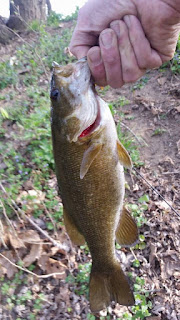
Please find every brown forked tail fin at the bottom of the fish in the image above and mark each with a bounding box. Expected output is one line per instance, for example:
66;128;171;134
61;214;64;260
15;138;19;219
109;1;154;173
89;263;134;312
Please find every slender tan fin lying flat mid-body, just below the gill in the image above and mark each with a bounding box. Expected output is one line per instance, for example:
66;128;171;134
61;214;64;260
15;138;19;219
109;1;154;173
80;142;102;179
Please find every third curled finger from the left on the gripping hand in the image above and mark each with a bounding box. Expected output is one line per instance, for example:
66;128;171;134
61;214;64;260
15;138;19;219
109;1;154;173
110;20;145;83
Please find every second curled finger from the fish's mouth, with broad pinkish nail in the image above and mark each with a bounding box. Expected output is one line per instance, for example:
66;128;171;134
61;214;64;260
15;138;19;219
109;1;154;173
99;28;124;88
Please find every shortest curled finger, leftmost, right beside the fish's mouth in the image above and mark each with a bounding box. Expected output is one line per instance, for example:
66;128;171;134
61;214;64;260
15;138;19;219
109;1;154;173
87;46;107;87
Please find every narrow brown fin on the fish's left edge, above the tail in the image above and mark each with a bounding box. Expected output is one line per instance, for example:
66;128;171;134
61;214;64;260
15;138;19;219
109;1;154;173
63;208;85;246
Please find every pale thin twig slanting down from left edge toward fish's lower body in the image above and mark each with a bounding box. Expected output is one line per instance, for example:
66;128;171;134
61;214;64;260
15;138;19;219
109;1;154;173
0;183;67;254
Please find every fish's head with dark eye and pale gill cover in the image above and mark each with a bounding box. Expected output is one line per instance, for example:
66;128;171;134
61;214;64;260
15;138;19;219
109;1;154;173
50;58;98;142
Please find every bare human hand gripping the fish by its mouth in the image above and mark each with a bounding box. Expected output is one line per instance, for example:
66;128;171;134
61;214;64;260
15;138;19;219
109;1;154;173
70;0;180;88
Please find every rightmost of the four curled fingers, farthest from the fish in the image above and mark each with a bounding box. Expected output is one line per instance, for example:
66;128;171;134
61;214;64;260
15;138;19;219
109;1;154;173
123;15;162;69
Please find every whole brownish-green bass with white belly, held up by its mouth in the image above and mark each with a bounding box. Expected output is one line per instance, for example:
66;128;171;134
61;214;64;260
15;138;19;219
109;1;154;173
50;58;138;312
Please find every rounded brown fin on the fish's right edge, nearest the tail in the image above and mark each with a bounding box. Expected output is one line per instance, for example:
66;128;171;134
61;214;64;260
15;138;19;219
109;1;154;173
116;207;138;247
